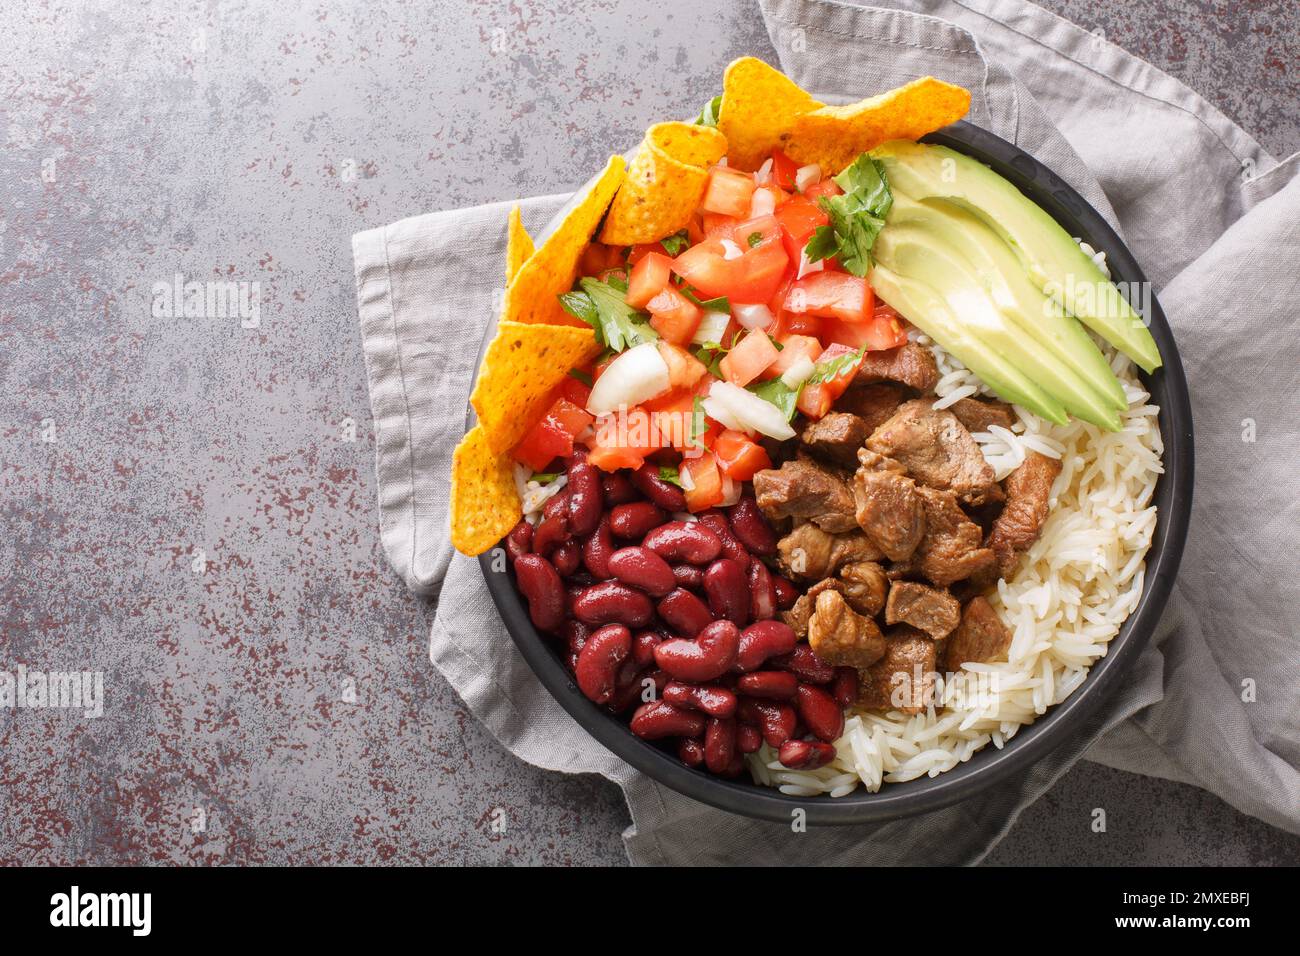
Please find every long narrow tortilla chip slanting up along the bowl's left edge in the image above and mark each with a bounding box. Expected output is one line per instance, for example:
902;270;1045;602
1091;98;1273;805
502;156;627;329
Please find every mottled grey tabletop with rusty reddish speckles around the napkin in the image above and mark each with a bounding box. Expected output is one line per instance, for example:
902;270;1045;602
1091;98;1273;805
0;0;1300;864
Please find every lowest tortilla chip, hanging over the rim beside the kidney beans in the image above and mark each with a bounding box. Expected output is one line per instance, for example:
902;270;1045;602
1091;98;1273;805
451;425;520;555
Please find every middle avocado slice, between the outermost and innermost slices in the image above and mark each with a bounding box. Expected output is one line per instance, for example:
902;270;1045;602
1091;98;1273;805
888;193;1128;424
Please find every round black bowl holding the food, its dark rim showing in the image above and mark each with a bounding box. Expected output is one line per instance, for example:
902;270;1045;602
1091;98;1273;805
471;122;1192;825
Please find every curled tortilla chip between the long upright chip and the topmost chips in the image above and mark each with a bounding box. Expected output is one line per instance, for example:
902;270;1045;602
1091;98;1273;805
601;122;727;246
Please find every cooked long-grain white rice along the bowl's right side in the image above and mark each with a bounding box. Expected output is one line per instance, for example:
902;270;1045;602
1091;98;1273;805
748;332;1164;796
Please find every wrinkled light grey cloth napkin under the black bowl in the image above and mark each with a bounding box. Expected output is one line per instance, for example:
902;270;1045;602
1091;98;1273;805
354;0;1300;864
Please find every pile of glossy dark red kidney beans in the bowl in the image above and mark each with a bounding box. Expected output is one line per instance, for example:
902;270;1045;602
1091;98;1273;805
506;450;858;777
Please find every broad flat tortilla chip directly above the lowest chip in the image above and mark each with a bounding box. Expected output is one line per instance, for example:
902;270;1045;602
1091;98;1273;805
469;321;601;451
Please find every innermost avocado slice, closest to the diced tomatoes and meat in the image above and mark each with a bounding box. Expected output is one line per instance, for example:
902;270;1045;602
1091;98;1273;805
868;219;1119;431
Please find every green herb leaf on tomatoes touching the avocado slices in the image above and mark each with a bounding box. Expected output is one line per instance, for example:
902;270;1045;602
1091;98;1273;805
803;153;893;276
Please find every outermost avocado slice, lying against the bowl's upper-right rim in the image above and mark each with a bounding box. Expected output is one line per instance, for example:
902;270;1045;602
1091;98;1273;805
871;140;1161;372
